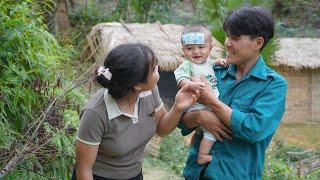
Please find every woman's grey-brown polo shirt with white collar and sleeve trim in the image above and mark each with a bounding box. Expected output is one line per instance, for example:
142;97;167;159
77;86;162;179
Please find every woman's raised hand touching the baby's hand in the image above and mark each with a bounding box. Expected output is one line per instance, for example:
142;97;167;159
175;84;200;111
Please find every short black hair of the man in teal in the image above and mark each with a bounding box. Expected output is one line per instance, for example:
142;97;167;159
223;6;274;50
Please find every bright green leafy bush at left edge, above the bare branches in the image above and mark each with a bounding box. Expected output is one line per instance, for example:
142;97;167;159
0;1;65;132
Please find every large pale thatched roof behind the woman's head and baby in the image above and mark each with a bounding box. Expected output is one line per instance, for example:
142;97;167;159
87;22;222;71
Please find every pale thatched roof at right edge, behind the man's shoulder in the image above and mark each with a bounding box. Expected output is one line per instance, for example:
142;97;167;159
274;38;320;70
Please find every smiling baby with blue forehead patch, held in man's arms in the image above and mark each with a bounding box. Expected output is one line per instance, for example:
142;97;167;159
174;25;226;164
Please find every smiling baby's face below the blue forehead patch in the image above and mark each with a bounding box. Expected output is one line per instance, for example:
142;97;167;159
182;41;212;64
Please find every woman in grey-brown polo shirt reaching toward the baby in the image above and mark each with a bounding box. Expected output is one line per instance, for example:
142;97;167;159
72;44;199;180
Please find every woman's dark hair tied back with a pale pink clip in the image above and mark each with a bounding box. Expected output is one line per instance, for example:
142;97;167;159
96;43;158;99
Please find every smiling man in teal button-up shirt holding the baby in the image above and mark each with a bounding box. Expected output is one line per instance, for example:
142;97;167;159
179;7;287;180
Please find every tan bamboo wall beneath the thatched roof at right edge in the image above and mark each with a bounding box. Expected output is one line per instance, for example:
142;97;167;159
276;68;320;123
